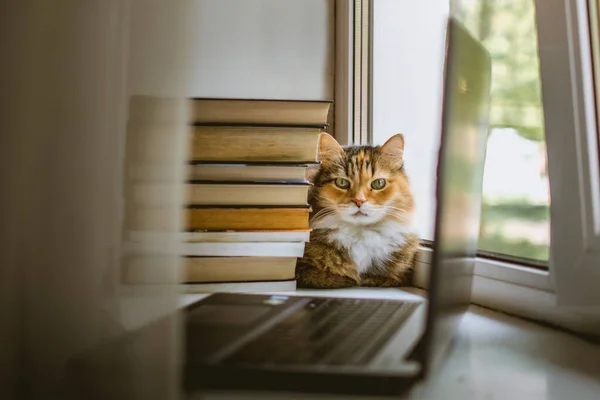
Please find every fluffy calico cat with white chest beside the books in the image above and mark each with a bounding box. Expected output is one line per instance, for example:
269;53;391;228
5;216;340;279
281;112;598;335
296;133;419;288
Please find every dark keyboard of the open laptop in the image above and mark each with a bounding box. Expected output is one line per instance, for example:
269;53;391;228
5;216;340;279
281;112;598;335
223;298;419;365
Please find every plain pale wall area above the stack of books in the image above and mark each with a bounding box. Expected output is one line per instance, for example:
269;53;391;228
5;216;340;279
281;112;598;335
131;0;334;100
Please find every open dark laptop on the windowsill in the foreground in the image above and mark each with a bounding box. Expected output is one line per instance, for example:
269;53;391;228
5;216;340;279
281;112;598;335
183;18;491;394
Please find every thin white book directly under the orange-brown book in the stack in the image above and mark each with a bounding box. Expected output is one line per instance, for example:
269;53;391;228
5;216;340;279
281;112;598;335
128;229;311;243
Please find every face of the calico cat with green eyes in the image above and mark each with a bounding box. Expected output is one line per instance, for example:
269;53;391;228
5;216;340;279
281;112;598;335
311;134;414;229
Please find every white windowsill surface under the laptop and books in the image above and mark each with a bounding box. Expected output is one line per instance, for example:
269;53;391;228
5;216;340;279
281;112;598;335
182;288;600;400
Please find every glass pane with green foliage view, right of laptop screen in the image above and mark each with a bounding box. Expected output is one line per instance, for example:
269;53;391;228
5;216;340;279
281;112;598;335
457;0;550;261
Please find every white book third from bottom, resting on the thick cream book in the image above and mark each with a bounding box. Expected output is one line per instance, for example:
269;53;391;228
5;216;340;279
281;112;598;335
123;242;304;257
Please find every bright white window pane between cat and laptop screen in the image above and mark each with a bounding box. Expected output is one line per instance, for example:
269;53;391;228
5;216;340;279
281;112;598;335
371;0;449;240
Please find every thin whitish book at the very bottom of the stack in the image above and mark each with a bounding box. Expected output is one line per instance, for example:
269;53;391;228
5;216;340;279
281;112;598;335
179;280;296;294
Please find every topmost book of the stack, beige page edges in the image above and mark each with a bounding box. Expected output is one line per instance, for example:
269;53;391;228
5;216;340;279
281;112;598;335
129;96;332;126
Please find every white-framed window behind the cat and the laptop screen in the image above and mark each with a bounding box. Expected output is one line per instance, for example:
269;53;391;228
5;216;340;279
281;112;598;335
336;0;600;333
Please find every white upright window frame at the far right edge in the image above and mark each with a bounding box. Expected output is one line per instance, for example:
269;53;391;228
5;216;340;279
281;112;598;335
535;0;600;310
